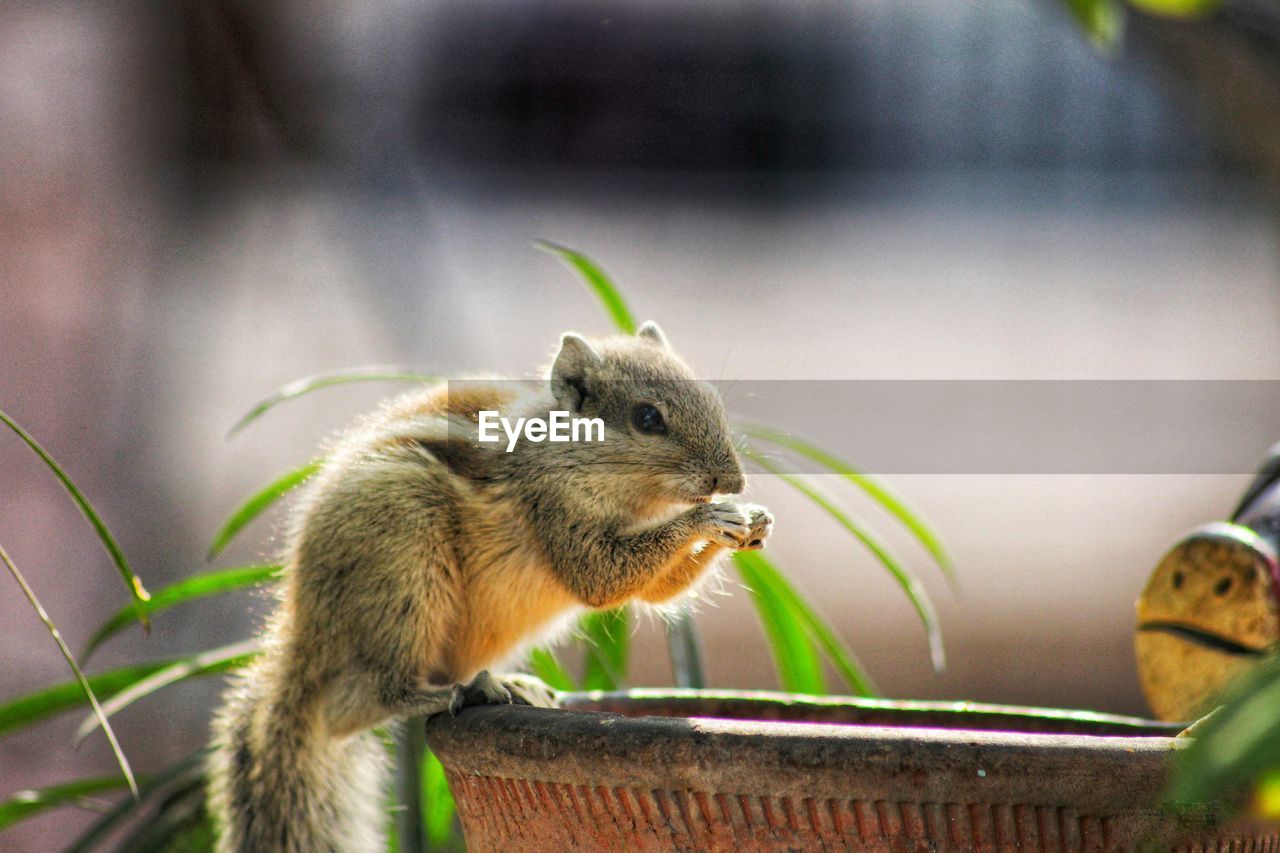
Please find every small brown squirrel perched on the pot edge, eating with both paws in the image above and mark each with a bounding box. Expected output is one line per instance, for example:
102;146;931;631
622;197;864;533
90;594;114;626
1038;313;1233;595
207;323;773;853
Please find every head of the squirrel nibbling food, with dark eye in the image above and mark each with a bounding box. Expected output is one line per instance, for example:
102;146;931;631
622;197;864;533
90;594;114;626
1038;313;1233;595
550;321;746;503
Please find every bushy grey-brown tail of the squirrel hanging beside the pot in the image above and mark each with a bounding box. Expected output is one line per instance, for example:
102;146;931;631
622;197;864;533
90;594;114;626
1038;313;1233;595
209;649;388;853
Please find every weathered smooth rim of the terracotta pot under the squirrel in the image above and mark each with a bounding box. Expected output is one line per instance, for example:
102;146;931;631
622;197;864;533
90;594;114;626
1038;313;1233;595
428;690;1184;811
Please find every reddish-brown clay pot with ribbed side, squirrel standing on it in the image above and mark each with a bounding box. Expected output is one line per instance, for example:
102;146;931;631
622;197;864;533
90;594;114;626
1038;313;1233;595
428;690;1280;850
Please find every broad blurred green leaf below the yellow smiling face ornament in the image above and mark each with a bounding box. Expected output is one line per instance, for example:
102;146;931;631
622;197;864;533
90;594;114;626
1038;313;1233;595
1167;656;1280;803
